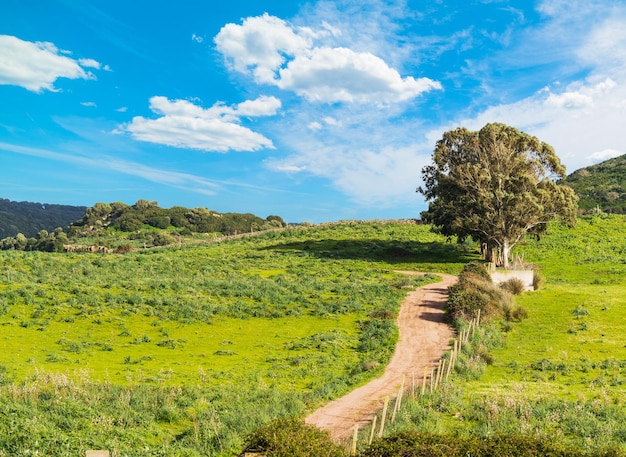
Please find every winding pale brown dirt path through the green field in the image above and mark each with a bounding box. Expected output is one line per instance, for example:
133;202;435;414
305;271;457;441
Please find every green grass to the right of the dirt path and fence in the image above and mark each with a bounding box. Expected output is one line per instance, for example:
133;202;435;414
378;216;626;455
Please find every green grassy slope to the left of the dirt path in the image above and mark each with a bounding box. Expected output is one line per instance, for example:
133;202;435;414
0;223;472;456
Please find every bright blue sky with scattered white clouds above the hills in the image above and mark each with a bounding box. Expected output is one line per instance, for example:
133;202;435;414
0;0;626;222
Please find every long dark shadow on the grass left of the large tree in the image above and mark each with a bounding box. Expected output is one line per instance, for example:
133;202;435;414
264;239;477;265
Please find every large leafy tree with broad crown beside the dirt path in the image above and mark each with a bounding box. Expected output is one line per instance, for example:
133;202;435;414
418;123;578;268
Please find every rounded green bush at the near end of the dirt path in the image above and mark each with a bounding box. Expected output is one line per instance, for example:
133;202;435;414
244;418;346;457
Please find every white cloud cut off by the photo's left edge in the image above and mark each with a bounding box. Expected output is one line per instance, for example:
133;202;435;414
0;35;100;92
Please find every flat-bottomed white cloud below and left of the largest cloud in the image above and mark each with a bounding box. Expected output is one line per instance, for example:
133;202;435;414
117;96;281;152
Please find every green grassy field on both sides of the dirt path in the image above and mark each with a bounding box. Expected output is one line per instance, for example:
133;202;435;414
0;215;626;457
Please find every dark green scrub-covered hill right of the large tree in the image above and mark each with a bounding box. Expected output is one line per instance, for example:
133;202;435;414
563;155;626;214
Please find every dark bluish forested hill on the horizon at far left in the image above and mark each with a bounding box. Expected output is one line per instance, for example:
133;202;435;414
0;198;87;239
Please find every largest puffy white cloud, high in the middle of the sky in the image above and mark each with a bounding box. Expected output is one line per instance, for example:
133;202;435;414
214;14;442;104
